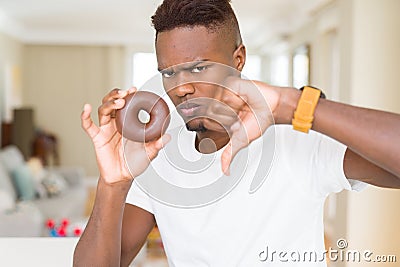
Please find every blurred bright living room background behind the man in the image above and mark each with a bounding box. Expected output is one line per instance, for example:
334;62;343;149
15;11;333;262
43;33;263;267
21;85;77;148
0;0;400;266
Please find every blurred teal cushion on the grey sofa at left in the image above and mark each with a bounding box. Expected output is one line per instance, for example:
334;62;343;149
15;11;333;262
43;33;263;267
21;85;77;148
11;164;35;200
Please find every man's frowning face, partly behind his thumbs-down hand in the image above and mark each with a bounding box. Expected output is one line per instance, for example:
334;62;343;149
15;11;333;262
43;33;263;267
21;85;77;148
156;26;245;132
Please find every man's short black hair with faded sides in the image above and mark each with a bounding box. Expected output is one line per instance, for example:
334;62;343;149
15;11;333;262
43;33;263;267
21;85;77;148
151;0;242;46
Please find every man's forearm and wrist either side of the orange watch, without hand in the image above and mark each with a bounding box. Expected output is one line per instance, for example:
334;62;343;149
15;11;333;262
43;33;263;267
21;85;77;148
274;89;400;177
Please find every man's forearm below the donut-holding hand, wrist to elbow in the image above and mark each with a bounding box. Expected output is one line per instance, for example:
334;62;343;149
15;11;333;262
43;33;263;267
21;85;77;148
74;179;132;267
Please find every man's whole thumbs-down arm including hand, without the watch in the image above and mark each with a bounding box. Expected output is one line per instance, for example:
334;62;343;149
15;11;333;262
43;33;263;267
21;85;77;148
222;81;400;188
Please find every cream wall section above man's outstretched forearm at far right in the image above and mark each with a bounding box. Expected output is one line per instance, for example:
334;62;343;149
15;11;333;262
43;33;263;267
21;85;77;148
351;0;400;112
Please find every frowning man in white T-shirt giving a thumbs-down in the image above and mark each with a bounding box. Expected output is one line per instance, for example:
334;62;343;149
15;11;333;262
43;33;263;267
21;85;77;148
74;0;400;266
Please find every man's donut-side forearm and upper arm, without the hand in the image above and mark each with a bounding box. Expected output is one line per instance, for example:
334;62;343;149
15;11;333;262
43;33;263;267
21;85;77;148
74;180;155;266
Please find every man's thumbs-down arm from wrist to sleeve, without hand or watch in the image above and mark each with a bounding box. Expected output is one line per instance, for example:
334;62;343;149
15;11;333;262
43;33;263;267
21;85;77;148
274;89;400;188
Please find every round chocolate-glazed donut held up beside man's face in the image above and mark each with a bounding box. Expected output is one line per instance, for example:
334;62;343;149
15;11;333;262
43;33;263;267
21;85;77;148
115;91;170;143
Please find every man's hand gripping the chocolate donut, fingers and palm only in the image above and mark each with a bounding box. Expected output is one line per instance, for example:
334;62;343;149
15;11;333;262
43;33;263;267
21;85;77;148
81;88;170;184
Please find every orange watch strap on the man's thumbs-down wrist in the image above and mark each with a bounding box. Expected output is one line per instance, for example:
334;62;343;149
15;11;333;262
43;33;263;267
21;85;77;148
292;86;321;133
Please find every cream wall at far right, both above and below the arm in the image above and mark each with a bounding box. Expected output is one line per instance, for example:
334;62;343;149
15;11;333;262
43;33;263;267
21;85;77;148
347;0;400;266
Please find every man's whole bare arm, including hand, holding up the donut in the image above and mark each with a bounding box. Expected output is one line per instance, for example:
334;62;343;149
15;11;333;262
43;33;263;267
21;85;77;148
74;88;169;267
